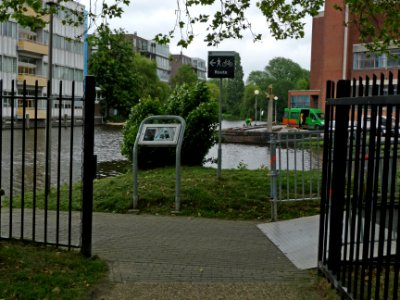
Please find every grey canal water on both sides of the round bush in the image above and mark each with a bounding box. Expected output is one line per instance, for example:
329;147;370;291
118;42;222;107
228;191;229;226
1;121;318;191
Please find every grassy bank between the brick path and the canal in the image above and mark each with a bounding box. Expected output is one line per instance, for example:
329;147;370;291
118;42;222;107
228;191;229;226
3;167;320;220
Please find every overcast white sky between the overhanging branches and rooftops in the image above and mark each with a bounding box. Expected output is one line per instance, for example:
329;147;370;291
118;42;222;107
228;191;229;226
81;0;311;80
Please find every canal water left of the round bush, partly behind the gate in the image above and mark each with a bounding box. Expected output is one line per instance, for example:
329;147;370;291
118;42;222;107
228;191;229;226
0;126;128;195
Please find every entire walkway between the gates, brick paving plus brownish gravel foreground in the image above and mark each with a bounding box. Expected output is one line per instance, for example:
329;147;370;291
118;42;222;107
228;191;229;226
92;213;324;299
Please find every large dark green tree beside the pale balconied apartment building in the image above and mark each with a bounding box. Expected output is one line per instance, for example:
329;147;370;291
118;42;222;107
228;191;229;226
89;26;170;119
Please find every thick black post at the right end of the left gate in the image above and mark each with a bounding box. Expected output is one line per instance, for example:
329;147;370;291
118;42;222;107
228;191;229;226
81;76;96;256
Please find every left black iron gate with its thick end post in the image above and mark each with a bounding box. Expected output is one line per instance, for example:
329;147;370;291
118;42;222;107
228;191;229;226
0;76;96;256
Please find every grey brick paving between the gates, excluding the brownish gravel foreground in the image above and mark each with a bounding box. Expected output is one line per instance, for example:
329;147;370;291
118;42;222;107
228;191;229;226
92;213;311;283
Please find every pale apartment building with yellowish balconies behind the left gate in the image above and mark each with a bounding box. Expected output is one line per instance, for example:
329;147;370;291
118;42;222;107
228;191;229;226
0;2;87;118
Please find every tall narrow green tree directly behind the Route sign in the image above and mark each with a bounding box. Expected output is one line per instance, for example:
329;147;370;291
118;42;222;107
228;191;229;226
223;53;244;116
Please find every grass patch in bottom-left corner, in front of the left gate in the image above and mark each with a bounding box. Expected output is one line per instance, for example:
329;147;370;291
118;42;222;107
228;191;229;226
0;241;108;300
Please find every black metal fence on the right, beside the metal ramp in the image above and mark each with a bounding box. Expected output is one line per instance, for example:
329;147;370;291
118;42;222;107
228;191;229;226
318;72;400;299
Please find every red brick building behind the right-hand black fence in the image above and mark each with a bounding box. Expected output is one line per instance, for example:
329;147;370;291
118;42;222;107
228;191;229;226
288;0;400;109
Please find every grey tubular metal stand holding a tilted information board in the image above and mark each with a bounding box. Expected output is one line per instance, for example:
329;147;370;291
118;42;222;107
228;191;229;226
132;115;186;213
